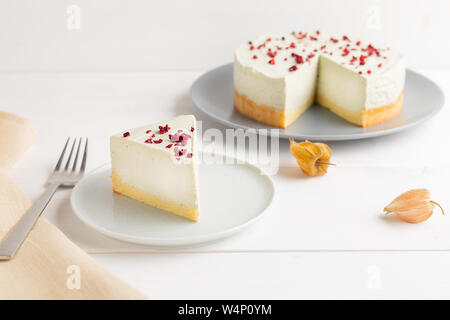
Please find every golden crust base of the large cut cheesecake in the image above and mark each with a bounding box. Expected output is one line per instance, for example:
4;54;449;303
234;89;403;128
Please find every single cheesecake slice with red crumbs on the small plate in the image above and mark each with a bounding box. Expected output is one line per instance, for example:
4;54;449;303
110;115;199;221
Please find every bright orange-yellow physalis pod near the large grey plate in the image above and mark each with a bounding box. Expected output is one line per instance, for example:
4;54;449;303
289;139;332;177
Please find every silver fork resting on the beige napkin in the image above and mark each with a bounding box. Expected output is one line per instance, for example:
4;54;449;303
0;137;88;260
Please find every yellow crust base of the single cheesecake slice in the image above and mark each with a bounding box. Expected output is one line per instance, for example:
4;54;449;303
111;171;198;221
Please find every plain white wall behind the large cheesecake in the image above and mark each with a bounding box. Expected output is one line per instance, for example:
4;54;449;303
0;0;450;71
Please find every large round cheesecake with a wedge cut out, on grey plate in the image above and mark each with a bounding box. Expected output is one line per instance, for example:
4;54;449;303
234;31;405;128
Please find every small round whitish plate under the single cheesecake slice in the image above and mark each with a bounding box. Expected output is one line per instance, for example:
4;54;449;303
71;156;275;247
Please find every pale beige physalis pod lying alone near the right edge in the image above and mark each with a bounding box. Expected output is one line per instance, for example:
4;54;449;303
384;189;444;223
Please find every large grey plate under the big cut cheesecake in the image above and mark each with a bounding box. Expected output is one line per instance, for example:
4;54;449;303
191;63;444;141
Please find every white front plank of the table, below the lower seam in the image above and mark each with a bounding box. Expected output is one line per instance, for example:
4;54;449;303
95;253;450;299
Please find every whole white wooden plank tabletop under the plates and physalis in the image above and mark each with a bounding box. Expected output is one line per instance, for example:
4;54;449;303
0;69;450;299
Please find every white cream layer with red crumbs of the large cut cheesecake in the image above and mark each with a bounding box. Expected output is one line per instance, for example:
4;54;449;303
234;31;405;111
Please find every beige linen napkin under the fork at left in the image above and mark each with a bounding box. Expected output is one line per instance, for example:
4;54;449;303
0;112;145;299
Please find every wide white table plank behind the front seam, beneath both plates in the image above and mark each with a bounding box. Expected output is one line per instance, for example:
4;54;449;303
0;71;450;252
